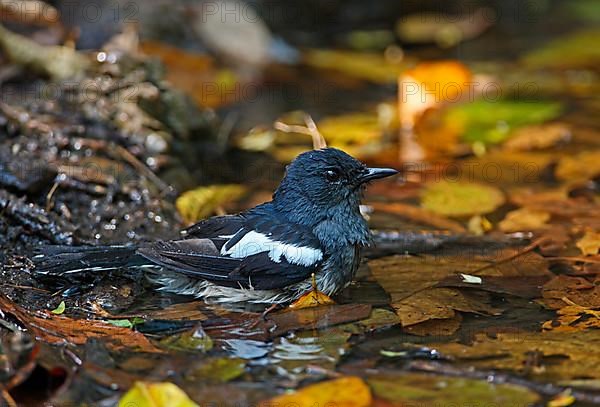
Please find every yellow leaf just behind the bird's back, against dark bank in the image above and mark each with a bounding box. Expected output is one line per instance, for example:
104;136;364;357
175;185;246;223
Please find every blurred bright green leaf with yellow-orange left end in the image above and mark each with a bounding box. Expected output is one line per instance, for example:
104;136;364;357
444;100;562;144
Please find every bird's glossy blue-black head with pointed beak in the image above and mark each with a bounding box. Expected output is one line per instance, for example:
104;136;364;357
273;148;398;222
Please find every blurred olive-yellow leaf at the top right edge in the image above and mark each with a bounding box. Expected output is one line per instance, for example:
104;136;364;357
523;30;600;68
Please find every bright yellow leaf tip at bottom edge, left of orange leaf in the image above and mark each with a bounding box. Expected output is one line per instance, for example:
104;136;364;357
119;382;198;407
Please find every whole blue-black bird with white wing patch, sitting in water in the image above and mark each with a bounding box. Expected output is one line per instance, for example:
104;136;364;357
33;148;397;304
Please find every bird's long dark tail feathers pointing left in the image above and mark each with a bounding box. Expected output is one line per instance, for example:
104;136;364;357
32;246;151;277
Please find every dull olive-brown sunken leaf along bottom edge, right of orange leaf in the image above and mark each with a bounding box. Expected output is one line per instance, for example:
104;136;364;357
367;373;539;407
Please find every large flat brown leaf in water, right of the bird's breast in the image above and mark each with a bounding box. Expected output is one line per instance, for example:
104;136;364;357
369;253;548;326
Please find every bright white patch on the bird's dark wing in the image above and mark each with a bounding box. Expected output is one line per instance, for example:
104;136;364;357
221;230;323;267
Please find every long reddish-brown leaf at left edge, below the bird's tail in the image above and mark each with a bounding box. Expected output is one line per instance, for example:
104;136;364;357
0;296;162;353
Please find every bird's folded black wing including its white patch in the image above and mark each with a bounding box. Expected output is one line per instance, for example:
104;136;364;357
138;217;323;290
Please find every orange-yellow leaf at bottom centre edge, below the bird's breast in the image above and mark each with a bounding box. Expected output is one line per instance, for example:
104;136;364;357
261;376;372;407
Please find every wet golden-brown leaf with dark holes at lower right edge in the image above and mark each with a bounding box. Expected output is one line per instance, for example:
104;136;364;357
431;329;600;381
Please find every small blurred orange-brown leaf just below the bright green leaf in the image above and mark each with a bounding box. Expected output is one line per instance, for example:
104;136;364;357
504;123;571;151
